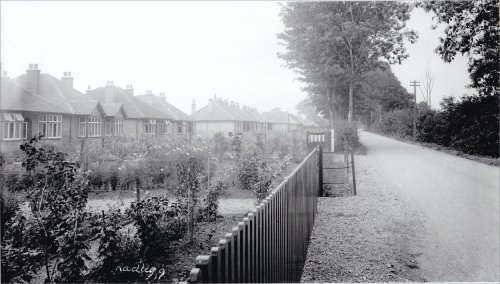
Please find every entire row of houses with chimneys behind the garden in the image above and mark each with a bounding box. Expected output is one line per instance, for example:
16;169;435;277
0;64;317;152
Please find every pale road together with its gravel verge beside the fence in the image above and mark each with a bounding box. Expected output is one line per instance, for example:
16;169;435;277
303;132;500;282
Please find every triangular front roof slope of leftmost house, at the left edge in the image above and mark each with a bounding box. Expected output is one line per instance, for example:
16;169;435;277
0;78;71;114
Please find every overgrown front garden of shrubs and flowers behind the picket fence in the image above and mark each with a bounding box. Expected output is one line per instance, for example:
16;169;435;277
0;130;306;283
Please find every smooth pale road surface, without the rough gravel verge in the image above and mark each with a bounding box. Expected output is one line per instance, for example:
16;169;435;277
359;132;500;282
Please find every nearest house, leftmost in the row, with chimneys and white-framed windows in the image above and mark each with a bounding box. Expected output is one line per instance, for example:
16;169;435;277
0;64;127;152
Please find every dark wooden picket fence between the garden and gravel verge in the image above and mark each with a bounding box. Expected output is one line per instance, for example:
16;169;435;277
188;148;322;283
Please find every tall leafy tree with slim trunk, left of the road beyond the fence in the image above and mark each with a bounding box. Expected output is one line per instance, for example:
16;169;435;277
278;2;417;121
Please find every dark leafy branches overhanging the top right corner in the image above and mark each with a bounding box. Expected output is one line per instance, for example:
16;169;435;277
418;0;500;95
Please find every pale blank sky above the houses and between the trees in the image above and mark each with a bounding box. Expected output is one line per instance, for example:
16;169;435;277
0;1;470;113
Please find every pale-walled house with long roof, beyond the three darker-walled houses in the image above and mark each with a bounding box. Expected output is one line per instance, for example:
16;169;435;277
191;97;267;137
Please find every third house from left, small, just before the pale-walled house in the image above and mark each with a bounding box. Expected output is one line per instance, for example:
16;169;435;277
135;90;195;139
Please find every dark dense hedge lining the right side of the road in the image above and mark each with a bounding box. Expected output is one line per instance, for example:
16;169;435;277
375;96;499;157
